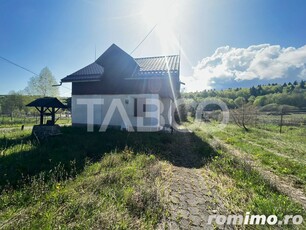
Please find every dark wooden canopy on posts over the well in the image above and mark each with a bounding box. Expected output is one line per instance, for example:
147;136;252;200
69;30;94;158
26;97;67;125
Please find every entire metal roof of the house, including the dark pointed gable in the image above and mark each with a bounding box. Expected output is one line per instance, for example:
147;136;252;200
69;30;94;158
62;44;180;82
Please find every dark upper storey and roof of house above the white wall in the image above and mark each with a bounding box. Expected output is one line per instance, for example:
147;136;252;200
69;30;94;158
62;44;180;99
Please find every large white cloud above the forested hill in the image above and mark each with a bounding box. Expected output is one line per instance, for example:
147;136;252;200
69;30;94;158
182;44;306;91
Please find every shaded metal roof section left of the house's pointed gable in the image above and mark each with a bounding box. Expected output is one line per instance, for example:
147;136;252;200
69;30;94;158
62;62;104;82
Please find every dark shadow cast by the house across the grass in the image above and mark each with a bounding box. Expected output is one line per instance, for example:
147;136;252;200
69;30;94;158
0;127;216;191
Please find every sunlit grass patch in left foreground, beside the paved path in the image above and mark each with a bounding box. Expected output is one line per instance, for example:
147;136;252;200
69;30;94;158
0;149;163;229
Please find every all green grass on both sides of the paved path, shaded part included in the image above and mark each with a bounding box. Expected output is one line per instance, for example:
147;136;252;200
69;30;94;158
0;124;306;229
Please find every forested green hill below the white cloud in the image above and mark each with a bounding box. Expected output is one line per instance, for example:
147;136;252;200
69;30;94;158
182;80;306;108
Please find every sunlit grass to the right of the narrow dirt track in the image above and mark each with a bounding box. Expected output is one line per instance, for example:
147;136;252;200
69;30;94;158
203;125;306;191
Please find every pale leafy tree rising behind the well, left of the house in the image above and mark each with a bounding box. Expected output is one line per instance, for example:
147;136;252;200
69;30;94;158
25;67;59;97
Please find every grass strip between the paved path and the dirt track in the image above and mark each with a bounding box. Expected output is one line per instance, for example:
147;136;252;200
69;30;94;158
196;127;306;229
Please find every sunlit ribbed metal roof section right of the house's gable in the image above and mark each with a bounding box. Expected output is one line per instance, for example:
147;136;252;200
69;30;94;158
134;55;180;77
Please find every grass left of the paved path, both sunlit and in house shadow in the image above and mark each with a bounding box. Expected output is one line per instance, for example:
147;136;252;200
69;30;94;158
0;127;213;229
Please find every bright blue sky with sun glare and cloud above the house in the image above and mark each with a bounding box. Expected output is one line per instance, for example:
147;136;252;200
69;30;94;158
0;0;306;96
